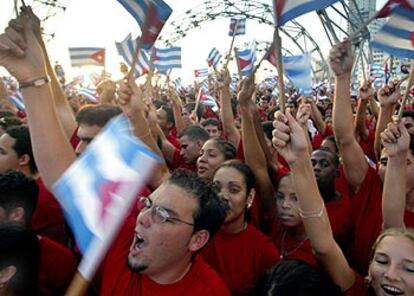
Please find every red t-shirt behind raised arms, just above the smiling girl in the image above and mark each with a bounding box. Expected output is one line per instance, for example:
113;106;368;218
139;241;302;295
349;167;414;275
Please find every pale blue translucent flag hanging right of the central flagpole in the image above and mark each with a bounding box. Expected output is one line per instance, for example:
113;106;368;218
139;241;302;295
282;53;312;95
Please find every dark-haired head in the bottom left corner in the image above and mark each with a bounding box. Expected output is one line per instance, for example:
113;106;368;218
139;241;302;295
0;222;40;296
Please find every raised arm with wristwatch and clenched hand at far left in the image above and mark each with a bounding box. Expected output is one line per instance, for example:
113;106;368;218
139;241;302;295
0;12;76;188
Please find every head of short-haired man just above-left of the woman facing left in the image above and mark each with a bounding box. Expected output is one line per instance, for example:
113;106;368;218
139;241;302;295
179;125;210;165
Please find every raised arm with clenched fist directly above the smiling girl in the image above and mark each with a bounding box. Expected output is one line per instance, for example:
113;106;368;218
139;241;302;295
381;122;410;229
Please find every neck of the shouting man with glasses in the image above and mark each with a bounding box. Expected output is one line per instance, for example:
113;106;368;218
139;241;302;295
148;253;193;285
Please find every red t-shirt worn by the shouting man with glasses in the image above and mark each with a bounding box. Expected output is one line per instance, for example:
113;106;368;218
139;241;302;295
101;217;230;296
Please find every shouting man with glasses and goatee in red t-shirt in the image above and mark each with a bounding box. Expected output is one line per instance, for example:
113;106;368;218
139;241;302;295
101;170;230;295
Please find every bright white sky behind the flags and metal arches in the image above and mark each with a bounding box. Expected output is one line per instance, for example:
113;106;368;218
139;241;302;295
0;0;385;83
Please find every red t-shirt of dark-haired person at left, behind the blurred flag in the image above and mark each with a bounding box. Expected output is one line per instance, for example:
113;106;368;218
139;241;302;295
32;178;68;245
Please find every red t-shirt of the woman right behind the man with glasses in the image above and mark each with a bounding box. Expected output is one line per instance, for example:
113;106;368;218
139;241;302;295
201;225;280;295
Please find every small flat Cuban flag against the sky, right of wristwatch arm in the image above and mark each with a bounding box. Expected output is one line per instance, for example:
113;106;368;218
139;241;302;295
69;47;105;67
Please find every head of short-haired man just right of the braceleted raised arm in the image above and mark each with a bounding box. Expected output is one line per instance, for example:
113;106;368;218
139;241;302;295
311;147;339;202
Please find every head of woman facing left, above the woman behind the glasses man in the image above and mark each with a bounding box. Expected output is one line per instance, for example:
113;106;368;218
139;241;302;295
197;138;236;180
